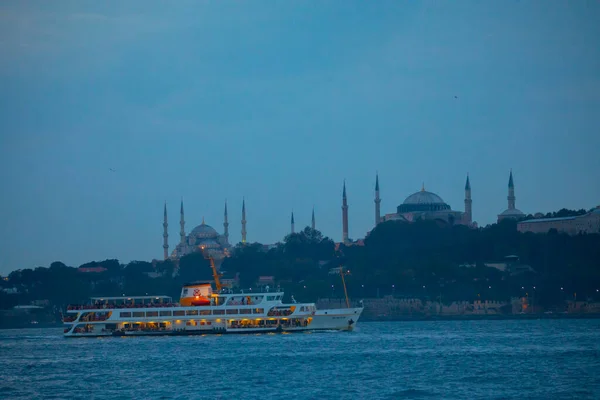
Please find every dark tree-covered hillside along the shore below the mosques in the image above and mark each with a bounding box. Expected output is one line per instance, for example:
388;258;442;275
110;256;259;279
0;214;600;308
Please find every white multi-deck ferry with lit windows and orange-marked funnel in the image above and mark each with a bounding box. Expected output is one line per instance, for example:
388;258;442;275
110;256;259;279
63;260;363;337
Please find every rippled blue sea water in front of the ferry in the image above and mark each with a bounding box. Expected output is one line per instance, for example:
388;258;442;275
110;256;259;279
0;319;600;400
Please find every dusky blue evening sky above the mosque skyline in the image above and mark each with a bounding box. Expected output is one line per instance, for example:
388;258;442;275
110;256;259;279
0;0;600;274
